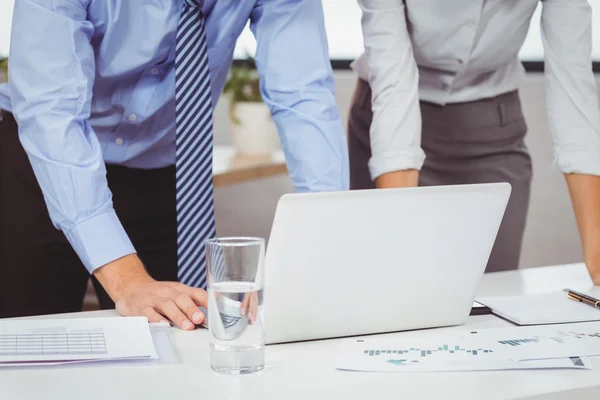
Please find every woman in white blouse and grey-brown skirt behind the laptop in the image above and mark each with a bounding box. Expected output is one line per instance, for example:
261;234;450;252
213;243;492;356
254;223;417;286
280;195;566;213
349;0;600;284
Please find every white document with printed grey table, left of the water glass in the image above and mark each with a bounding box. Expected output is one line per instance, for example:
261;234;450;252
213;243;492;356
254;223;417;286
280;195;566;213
0;317;158;367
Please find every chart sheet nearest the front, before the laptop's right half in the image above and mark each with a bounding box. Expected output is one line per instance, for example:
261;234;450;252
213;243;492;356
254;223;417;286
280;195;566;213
336;335;591;372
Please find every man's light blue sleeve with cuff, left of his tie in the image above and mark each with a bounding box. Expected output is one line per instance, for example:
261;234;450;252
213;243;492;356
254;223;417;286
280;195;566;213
9;0;135;272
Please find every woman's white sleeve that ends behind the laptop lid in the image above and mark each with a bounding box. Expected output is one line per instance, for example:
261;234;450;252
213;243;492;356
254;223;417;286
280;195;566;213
358;0;425;179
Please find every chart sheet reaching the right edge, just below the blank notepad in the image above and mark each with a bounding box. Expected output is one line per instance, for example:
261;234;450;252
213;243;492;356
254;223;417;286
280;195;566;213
461;322;600;361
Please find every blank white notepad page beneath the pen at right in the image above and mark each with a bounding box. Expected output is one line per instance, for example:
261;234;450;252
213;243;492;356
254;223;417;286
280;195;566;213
477;291;600;325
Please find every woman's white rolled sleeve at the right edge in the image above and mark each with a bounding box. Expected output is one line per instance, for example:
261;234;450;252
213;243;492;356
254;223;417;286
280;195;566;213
541;0;600;175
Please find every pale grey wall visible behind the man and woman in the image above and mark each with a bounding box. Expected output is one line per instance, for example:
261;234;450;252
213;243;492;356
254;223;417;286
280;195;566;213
215;72;600;267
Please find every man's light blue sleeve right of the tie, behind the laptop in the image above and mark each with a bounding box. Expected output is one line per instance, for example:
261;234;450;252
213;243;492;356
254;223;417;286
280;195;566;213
251;0;349;192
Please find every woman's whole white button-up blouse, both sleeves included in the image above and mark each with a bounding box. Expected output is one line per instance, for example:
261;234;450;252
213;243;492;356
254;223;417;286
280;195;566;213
353;0;600;179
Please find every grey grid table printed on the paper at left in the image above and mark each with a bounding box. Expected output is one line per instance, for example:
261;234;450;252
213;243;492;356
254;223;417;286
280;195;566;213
0;331;107;356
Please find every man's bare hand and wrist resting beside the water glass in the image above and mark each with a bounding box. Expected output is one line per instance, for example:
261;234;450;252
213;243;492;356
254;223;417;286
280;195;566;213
94;254;207;330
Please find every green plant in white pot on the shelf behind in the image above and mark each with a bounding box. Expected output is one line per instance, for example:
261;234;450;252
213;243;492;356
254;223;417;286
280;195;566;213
224;57;279;156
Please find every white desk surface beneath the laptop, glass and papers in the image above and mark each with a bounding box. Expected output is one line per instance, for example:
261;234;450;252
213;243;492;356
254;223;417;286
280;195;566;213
0;264;600;400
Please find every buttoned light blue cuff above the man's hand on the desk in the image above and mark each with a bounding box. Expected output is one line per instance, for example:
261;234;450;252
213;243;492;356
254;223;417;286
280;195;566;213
65;210;136;274
